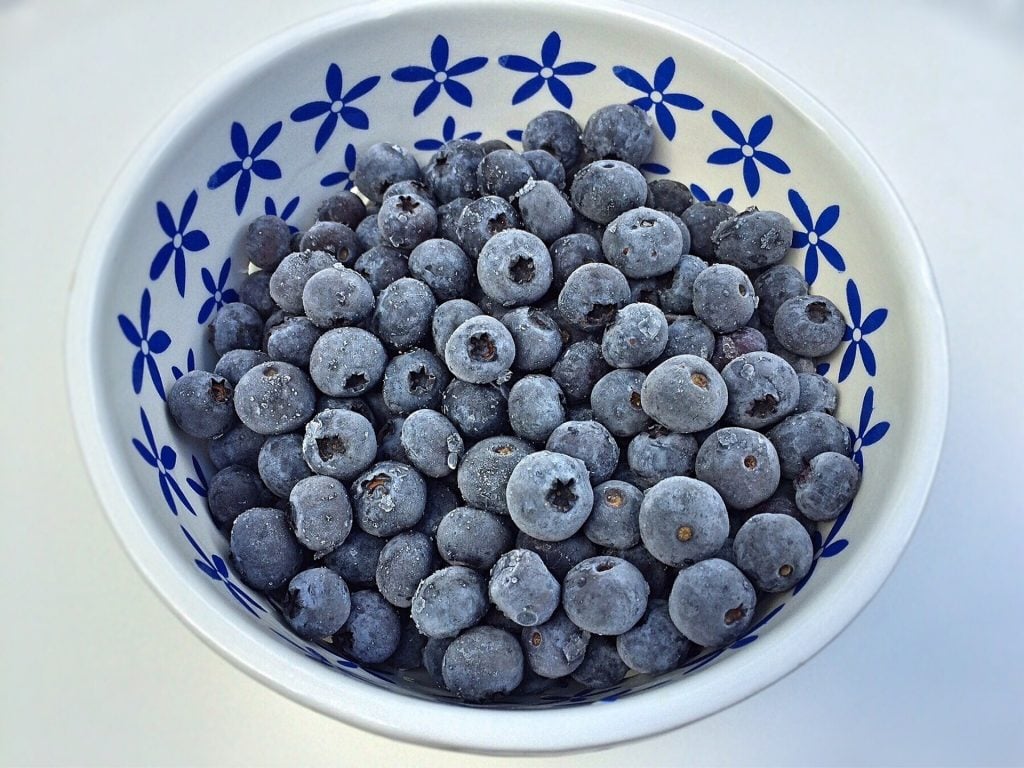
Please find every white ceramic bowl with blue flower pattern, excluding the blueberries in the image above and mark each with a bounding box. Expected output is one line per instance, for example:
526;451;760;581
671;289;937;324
68;0;947;753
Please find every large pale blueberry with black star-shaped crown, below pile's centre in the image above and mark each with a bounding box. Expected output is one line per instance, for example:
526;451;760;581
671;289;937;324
505;451;594;542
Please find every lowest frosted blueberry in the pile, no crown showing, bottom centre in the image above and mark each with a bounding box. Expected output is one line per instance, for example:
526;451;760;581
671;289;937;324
441;627;523;701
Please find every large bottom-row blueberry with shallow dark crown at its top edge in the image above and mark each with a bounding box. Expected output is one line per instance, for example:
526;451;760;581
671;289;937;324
562;555;650;635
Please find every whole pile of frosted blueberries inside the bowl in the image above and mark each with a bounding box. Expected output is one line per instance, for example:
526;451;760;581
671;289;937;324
168;104;859;701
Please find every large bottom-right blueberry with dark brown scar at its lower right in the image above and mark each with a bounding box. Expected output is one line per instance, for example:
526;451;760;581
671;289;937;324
669;559;757;648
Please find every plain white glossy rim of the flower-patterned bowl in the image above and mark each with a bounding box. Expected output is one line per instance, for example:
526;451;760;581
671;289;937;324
66;0;949;754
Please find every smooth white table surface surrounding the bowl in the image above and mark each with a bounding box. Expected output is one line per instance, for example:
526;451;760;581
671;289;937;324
0;0;1024;768
